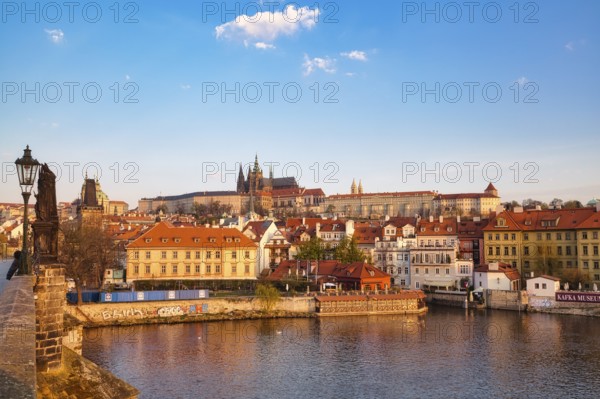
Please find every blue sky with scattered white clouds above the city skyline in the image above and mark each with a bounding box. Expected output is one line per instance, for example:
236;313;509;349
0;0;600;207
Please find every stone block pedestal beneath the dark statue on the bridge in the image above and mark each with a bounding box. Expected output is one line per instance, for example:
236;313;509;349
35;264;66;372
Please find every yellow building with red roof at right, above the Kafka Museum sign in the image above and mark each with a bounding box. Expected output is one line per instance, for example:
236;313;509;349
483;208;600;288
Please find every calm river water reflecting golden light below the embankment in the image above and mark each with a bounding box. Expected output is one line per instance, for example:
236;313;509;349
84;307;600;399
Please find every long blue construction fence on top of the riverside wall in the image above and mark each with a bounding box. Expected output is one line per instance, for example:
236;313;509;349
67;290;208;304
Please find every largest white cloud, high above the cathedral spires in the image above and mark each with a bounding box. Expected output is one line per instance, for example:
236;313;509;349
215;5;320;48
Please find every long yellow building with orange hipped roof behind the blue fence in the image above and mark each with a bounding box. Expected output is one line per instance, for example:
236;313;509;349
127;222;257;281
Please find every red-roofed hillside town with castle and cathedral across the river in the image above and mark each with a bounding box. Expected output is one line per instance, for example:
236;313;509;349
0;157;600;298
